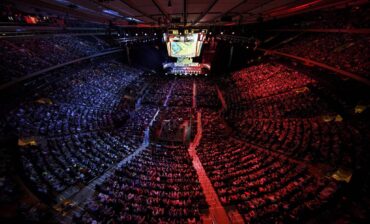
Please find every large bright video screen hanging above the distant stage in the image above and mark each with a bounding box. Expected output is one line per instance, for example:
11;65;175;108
163;33;204;58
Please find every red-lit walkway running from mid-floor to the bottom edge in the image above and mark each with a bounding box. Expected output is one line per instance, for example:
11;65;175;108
188;112;243;224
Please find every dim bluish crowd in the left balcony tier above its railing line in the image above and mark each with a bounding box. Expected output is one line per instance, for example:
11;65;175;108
0;35;110;84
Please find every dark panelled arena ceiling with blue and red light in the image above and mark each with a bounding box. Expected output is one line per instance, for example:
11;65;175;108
13;0;367;27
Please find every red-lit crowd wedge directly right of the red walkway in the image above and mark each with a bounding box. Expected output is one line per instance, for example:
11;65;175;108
197;110;338;223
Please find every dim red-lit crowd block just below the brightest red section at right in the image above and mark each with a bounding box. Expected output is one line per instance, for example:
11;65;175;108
231;118;361;167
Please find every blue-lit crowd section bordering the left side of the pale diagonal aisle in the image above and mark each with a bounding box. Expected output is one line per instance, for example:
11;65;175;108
20;132;142;201
